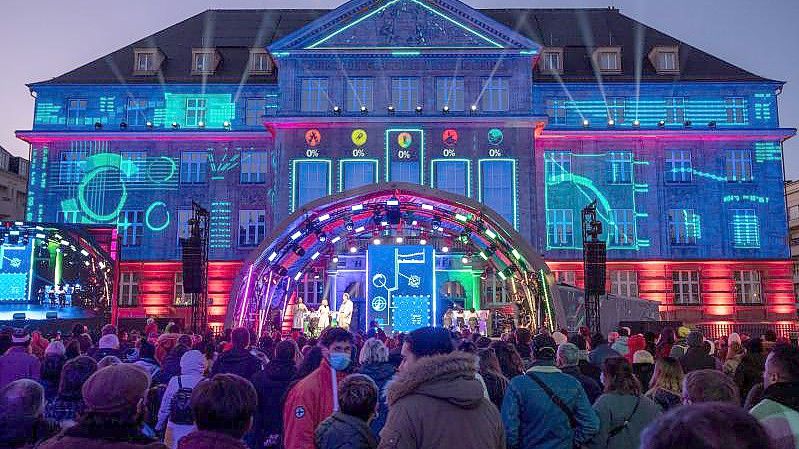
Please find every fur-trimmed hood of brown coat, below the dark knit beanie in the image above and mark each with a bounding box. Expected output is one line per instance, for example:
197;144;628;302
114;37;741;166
386;351;484;408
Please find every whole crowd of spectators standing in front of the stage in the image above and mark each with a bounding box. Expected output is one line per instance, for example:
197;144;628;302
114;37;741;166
0;321;799;449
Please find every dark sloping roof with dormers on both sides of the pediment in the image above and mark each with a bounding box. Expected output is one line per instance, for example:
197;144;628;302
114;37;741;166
36;8;770;85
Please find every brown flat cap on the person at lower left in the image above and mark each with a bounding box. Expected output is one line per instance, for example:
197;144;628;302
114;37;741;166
82;363;150;414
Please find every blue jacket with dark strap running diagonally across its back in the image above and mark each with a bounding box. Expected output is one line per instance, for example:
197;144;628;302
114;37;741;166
502;365;599;449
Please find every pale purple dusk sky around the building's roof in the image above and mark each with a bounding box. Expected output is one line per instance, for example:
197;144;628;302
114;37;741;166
0;0;799;179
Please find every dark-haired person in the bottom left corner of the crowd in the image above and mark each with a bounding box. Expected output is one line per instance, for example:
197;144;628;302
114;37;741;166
0;379;59;449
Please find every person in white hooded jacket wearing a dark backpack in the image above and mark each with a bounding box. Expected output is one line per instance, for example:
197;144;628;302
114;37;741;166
155;350;205;449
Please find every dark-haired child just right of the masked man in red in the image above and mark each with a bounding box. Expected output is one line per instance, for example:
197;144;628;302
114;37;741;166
315;374;378;449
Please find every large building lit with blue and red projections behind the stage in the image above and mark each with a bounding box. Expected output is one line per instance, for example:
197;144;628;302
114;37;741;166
18;0;796;326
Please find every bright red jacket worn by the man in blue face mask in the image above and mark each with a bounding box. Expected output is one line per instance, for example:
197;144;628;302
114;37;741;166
283;359;346;449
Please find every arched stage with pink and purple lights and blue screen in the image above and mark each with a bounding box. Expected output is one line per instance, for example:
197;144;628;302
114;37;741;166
225;183;563;335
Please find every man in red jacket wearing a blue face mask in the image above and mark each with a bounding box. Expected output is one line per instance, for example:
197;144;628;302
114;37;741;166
283;327;353;449
